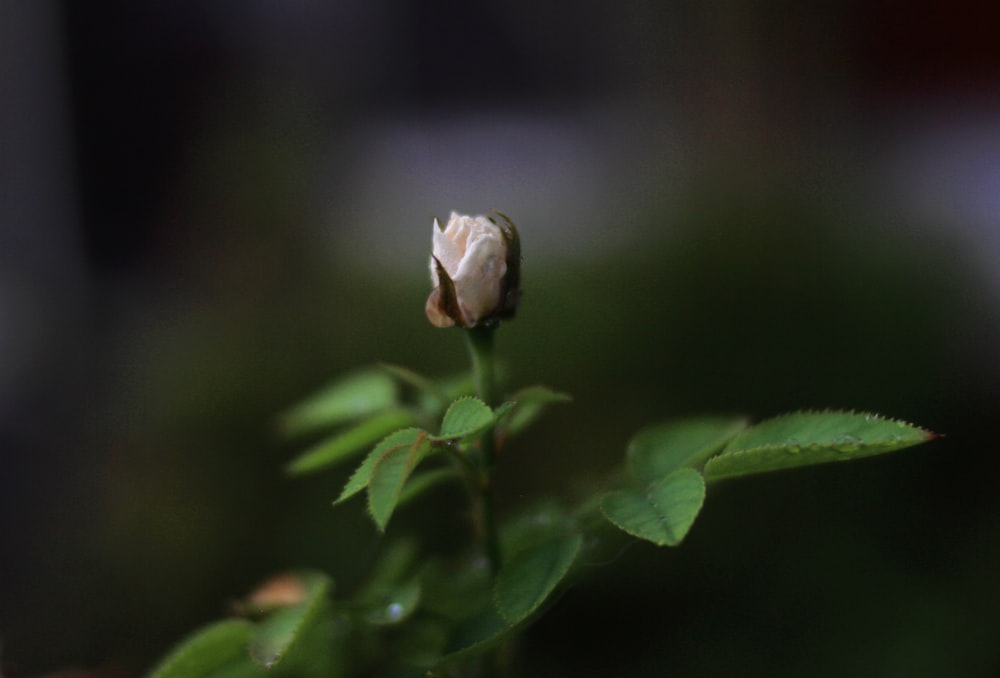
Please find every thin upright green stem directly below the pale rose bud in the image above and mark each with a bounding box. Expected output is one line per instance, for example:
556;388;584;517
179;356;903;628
465;325;502;576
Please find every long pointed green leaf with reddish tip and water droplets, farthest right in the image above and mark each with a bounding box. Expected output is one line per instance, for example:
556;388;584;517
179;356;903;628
705;411;935;480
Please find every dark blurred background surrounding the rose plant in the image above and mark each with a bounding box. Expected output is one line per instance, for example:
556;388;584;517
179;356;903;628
0;0;1000;677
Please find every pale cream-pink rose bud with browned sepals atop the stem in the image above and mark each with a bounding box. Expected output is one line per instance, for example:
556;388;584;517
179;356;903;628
426;212;521;327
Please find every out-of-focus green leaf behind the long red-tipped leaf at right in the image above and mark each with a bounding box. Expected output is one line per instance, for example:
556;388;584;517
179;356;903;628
625;417;747;482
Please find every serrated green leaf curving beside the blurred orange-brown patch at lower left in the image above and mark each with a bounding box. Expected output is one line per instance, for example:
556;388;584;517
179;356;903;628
250;572;331;669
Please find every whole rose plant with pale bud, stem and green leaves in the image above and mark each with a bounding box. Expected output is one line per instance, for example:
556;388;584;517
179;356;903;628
143;213;934;678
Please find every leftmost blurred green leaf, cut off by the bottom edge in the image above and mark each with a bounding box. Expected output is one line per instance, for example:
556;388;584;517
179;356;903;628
147;619;253;678
